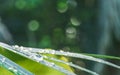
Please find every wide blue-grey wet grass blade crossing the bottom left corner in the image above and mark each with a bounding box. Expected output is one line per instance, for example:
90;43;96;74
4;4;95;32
0;54;33;75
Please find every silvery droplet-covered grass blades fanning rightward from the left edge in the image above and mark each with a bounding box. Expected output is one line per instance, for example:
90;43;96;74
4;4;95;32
0;43;120;75
